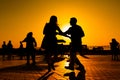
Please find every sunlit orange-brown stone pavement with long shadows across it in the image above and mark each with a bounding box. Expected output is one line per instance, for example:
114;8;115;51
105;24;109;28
0;55;120;80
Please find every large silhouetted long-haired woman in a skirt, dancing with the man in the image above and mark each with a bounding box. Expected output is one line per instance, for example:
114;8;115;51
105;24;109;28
41;16;62;71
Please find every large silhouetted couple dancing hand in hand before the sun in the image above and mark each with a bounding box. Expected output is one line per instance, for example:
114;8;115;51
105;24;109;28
41;16;85;72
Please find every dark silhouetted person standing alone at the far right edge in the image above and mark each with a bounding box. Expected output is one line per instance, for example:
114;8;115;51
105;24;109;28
110;38;119;60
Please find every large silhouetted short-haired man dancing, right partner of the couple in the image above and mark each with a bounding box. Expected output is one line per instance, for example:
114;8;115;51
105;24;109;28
65;17;85;71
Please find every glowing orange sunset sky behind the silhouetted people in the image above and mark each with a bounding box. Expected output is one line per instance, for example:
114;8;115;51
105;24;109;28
0;0;120;48
